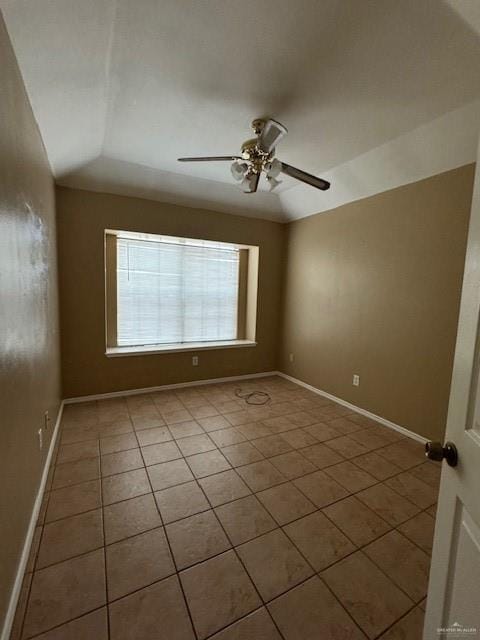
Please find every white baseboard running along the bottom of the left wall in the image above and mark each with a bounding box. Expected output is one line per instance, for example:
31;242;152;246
0;401;64;640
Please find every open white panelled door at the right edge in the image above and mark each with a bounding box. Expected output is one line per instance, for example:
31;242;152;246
423;146;480;640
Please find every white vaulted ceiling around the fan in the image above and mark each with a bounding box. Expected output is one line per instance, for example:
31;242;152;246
0;0;480;220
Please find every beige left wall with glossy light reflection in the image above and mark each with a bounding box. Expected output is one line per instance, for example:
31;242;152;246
0;14;60;626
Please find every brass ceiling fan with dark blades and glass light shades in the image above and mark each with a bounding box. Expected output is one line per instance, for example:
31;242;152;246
178;118;330;193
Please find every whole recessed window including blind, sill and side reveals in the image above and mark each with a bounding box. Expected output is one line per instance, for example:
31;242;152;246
105;231;258;355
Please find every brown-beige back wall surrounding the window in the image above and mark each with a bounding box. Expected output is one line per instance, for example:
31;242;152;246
57;187;285;398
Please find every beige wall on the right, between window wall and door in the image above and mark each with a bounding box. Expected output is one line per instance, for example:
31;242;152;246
280;165;474;439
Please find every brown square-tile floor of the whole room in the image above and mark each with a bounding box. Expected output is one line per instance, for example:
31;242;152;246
11;377;440;640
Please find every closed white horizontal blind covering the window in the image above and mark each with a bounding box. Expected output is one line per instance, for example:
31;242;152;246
117;237;239;346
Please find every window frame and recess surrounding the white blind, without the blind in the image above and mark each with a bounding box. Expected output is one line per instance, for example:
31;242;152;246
104;229;259;357
